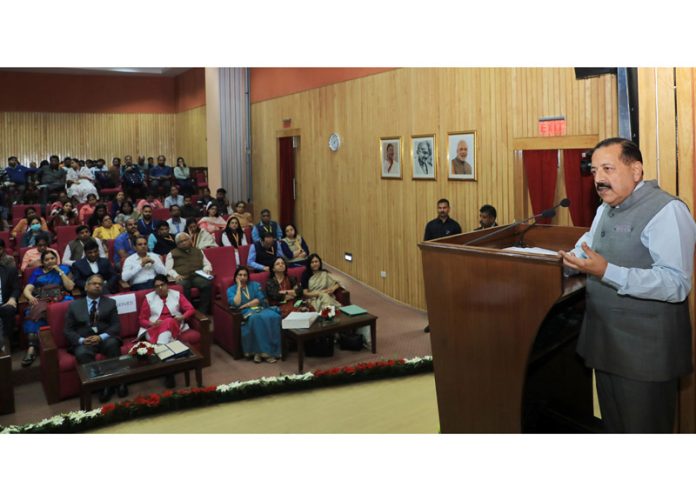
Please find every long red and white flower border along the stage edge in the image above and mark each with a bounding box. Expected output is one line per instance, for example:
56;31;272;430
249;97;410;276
0;354;433;433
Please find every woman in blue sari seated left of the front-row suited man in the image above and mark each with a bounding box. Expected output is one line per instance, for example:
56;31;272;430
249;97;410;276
22;249;75;367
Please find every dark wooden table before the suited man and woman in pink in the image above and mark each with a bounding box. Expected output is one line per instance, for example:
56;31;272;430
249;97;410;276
77;346;204;411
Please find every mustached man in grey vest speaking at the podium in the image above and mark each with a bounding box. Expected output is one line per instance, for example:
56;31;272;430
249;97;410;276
561;138;696;433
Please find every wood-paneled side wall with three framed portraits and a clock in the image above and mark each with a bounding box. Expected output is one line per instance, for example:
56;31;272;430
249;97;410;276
252;68;617;308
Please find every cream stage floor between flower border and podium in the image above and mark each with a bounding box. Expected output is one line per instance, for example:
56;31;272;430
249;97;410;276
89;374;439;433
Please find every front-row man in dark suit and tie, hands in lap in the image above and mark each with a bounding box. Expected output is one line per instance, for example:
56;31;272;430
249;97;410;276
65;274;128;403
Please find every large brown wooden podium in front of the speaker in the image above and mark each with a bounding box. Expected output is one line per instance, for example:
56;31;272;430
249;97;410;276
420;224;592;433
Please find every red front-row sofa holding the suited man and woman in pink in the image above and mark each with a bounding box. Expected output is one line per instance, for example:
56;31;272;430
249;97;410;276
39;285;211;404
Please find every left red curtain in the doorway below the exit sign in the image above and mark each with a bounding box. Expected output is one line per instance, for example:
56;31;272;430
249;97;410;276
522;150;558;224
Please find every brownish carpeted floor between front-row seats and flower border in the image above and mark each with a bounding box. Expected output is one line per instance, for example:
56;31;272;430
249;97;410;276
0;264;434;425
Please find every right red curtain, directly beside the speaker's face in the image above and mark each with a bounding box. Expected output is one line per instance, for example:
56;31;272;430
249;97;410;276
563;150;600;226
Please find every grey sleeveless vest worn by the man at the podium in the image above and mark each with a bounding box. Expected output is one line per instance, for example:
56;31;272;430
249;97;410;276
578;181;692;381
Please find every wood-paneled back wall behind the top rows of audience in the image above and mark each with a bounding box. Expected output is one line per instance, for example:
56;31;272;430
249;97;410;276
0;106;206;165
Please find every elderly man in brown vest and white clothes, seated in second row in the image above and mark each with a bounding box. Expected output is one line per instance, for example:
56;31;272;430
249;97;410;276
165;233;213;314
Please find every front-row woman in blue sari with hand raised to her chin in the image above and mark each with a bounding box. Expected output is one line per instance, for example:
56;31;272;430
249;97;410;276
227;266;281;363
